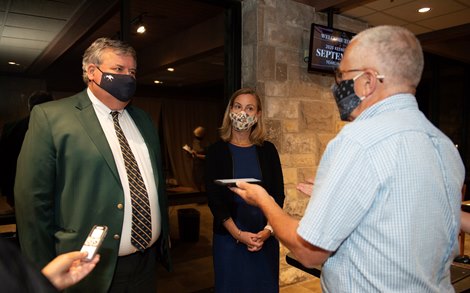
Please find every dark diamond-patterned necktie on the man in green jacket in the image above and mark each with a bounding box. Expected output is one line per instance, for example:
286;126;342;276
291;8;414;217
111;111;152;251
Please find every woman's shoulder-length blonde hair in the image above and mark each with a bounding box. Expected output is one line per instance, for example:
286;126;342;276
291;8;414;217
219;88;266;145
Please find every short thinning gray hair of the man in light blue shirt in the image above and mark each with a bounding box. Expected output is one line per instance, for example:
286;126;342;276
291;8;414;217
354;25;424;88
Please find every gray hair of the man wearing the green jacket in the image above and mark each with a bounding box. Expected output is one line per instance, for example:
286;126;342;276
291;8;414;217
82;38;137;84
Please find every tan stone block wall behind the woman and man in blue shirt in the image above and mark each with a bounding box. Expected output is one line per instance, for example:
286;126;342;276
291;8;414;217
242;0;367;286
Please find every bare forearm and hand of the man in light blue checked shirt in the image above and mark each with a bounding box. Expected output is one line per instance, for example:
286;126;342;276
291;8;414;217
231;181;331;267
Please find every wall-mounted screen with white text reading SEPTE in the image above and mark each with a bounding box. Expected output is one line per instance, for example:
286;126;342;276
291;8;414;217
308;23;355;73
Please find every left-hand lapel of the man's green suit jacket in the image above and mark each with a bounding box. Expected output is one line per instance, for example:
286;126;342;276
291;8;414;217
76;90;121;182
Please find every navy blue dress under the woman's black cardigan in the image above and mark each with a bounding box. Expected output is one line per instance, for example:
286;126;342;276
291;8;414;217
213;144;279;293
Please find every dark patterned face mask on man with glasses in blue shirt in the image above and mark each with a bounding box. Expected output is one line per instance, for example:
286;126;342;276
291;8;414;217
331;79;362;121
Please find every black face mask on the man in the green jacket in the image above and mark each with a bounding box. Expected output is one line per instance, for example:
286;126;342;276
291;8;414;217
93;67;136;102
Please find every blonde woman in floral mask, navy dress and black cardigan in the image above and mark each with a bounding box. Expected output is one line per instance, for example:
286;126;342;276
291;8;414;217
205;88;284;293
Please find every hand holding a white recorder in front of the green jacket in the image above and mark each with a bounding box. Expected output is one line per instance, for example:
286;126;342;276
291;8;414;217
41;251;100;290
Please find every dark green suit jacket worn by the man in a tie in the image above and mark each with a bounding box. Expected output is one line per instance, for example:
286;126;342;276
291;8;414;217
15;91;171;292
